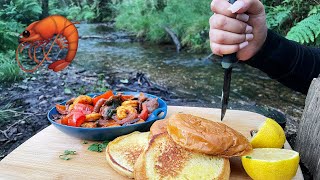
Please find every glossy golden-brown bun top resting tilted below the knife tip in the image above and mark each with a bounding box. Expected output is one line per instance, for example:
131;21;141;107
167;114;252;157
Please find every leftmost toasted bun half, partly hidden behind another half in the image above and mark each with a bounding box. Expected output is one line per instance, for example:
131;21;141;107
106;131;149;178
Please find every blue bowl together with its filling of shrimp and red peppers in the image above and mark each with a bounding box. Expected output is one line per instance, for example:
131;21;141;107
47;90;167;141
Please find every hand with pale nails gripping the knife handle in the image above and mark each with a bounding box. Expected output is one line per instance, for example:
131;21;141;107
209;0;268;61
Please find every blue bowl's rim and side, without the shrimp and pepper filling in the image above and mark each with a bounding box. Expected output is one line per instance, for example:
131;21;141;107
47;92;167;141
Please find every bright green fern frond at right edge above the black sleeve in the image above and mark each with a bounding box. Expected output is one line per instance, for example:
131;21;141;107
286;13;320;44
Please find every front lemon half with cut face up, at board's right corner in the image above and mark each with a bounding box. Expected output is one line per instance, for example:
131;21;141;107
241;148;300;180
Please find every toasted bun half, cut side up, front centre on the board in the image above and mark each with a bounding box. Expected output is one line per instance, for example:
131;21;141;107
134;132;230;180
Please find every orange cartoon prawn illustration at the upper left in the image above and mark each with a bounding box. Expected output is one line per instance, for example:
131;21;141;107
16;15;79;72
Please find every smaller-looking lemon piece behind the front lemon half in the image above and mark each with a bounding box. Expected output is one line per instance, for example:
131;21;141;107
250;118;286;148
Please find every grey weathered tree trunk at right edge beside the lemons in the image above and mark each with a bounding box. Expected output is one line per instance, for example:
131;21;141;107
295;77;320;179
